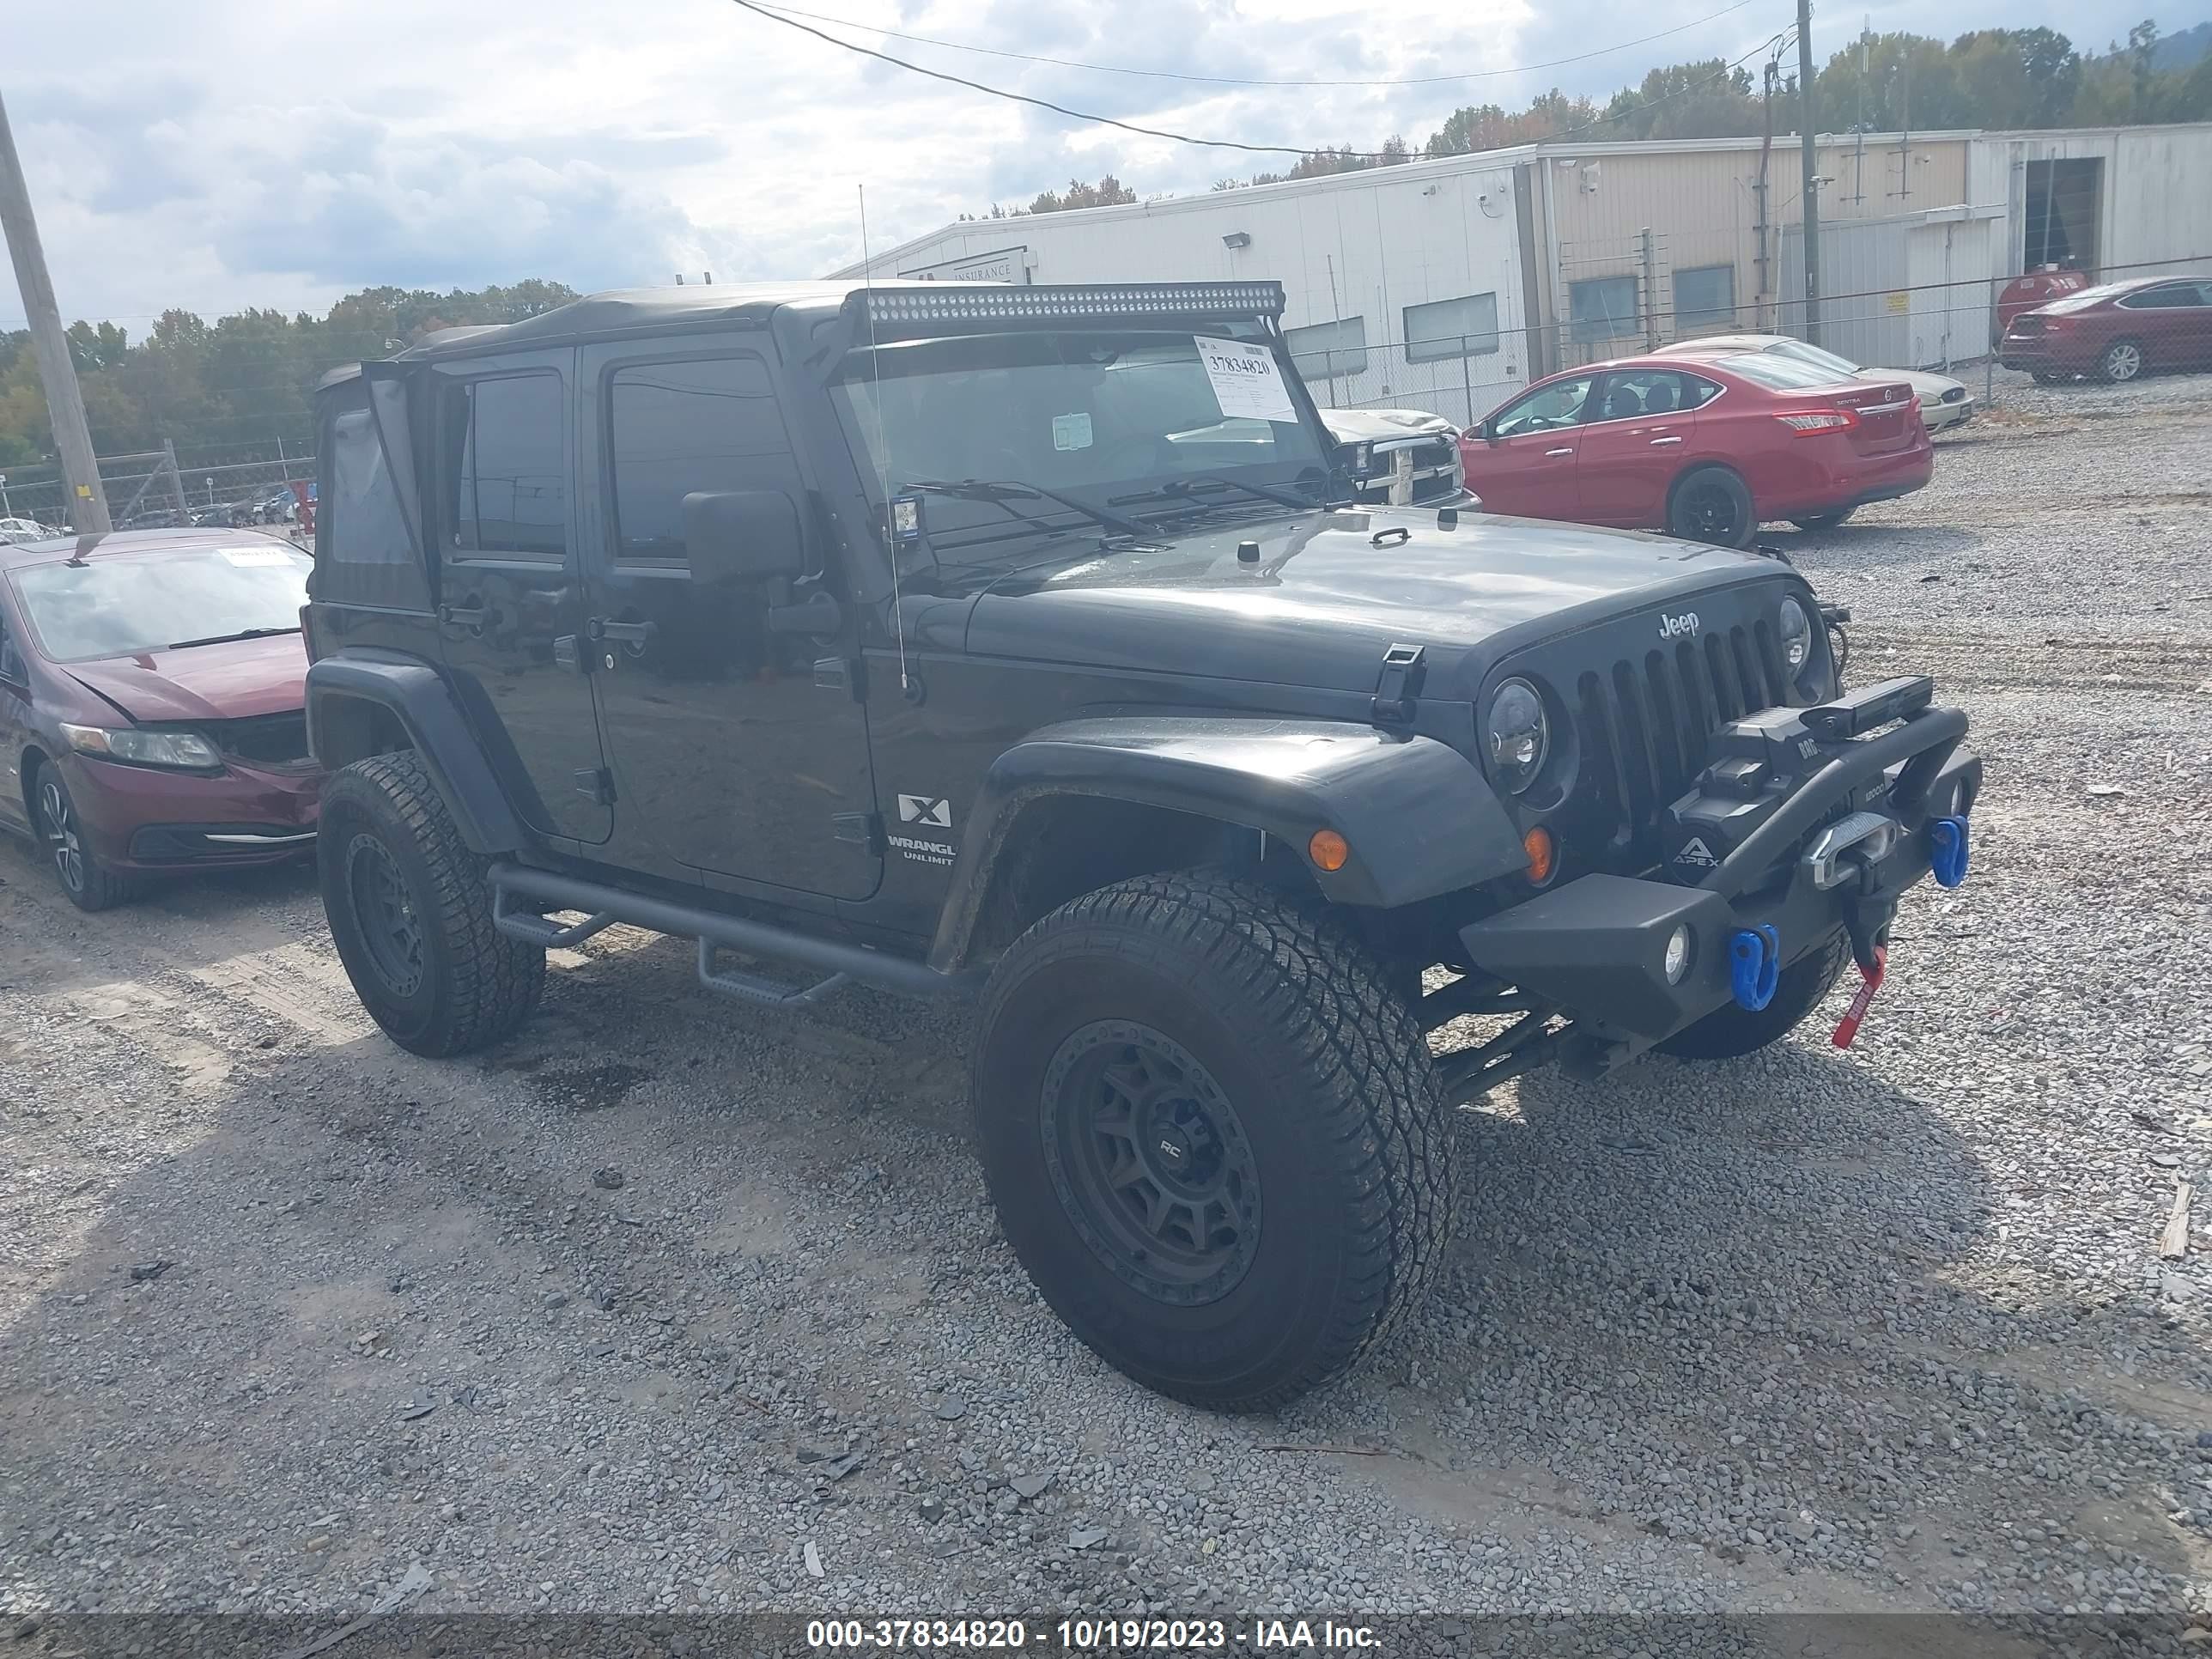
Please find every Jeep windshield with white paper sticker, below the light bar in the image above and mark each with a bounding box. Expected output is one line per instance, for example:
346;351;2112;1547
832;323;1328;562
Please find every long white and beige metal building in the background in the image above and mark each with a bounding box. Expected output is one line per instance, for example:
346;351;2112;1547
836;124;2212;420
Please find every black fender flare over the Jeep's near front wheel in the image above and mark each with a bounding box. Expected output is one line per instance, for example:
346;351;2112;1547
929;714;1528;971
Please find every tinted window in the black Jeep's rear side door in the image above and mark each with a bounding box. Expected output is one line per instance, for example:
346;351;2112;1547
442;374;568;560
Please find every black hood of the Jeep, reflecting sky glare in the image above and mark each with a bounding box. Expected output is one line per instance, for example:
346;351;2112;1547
967;508;1796;699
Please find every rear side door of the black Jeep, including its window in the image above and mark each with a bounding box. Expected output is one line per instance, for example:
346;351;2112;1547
431;347;615;842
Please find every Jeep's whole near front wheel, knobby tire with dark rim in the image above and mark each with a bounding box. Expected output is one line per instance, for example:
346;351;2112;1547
971;876;1453;1411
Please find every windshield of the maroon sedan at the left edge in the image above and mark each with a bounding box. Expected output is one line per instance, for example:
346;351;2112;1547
15;542;314;661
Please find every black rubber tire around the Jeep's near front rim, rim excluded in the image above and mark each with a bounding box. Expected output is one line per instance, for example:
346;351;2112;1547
971;872;1455;1411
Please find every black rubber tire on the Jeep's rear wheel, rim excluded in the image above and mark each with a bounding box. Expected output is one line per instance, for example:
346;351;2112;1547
316;752;546;1060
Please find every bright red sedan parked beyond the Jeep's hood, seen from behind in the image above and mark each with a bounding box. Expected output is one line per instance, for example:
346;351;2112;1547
1460;352;1936;546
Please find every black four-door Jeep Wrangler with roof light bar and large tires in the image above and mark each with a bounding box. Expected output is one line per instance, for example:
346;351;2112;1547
305;283;1980;1409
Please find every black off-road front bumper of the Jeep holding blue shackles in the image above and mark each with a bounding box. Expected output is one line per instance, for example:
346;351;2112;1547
1460;708;1982;1073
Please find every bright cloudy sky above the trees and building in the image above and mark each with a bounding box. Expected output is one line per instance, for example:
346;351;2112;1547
0;0;2212;334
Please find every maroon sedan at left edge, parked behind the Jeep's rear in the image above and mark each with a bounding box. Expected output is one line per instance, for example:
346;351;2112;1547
0;531;321;909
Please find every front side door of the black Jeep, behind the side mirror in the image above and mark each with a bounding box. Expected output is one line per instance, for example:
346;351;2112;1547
581;337;883;898
